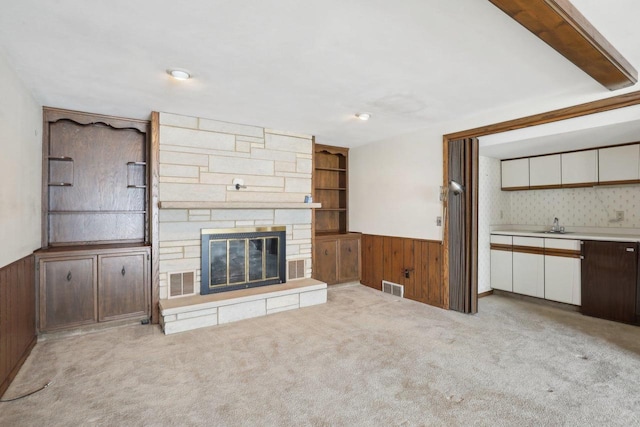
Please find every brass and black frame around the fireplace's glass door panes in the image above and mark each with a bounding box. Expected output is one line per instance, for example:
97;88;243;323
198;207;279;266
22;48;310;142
200;226;287;295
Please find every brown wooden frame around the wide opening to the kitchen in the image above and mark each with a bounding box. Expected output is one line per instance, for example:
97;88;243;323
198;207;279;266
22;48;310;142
442;91;640;309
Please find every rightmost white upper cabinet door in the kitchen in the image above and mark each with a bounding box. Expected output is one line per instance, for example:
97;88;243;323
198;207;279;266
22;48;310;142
598;144;640;182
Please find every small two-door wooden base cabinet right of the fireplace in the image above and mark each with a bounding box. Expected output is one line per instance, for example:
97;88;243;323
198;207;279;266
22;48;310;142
313;233;360;285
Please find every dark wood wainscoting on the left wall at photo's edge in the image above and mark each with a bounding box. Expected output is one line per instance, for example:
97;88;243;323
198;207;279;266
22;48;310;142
0;255;37;397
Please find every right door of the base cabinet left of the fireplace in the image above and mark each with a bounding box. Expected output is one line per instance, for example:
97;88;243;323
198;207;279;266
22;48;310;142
98;253;148;321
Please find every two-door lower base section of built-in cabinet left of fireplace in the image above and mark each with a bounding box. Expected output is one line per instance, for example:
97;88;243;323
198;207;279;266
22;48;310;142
36;247;150;332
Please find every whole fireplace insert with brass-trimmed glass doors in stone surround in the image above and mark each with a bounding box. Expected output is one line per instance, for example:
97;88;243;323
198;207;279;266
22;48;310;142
200;226;286;295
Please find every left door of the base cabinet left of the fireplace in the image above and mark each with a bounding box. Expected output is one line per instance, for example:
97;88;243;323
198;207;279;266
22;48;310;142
40;257;97;330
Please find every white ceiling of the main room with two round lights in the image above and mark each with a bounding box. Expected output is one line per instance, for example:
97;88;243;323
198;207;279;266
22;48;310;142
0;0;640;147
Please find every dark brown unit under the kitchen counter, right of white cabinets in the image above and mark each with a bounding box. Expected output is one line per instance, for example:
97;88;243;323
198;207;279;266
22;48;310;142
581;241;640;323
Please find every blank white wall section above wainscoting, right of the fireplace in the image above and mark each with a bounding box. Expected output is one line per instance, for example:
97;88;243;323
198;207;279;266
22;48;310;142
349;130;442;240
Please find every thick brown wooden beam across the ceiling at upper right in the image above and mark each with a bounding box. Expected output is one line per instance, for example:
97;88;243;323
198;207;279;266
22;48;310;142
489;0;638;90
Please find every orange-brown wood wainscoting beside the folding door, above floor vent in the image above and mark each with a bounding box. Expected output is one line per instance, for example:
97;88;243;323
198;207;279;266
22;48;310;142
360;234;444;308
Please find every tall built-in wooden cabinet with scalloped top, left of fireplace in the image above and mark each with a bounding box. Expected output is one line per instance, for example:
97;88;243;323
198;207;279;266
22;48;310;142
36;108;152;331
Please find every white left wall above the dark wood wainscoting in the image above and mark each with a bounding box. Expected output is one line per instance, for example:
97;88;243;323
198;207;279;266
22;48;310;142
0;51;42;268
